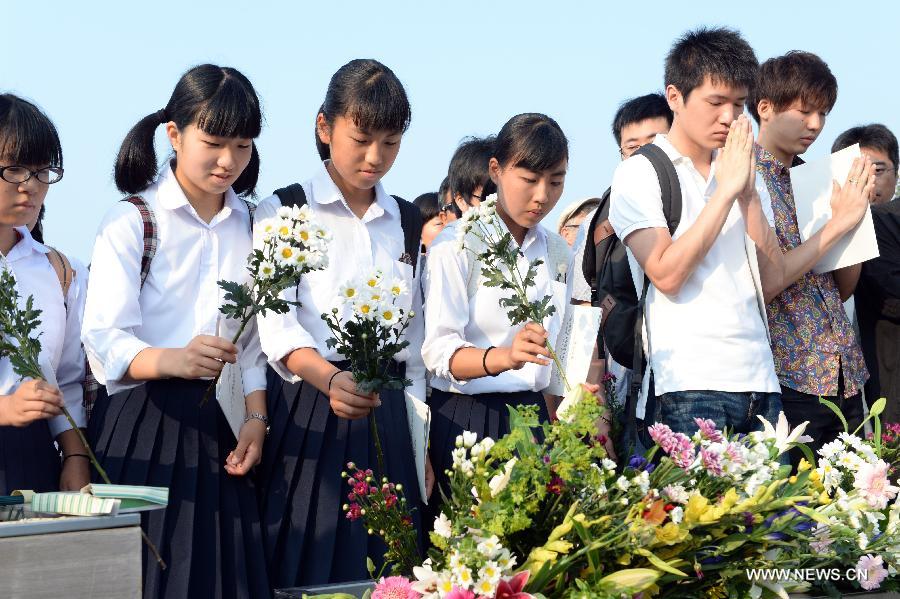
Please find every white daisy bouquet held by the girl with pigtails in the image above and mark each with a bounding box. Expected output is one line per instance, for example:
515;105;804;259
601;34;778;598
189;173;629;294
202;206;331;403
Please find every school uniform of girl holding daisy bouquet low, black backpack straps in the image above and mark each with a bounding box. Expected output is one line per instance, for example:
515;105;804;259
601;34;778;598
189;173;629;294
256;163;425;588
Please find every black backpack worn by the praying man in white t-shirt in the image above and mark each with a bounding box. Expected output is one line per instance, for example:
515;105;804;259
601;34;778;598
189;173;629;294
582;144;681;418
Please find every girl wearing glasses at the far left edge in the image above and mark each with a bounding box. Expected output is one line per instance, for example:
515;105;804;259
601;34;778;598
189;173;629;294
0;94;90;495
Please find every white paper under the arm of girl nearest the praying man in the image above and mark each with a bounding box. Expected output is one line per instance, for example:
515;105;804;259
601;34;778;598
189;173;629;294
546;304;601;396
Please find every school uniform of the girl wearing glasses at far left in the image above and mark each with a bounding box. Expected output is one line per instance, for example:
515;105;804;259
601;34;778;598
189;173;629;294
0;227;87;495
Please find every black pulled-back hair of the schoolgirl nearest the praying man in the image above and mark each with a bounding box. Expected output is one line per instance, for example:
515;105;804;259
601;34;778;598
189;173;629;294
493;112;569;173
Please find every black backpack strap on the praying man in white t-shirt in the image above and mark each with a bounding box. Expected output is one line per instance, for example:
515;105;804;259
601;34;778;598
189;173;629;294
627;144;681;442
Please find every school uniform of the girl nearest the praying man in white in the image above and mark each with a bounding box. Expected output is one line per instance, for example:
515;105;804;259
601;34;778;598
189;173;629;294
422;220;570;504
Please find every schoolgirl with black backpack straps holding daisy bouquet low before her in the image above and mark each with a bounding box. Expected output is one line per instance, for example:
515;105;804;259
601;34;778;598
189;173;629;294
256;59;430;587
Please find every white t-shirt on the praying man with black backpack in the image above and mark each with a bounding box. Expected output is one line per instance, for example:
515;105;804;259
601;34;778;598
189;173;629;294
609;135;779;411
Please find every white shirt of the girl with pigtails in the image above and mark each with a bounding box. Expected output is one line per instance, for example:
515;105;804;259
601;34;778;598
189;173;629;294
82;166;266;394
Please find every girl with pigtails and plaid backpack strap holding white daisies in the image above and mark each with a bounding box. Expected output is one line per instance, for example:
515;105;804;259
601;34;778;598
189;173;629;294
82;65;271;599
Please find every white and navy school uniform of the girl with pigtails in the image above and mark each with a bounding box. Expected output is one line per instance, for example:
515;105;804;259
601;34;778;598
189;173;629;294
82;167;270;598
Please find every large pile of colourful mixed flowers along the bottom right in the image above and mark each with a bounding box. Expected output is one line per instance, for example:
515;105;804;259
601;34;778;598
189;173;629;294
342;386;900;599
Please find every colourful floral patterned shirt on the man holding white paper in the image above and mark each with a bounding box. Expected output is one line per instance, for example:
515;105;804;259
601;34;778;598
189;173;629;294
756;145;869;397
